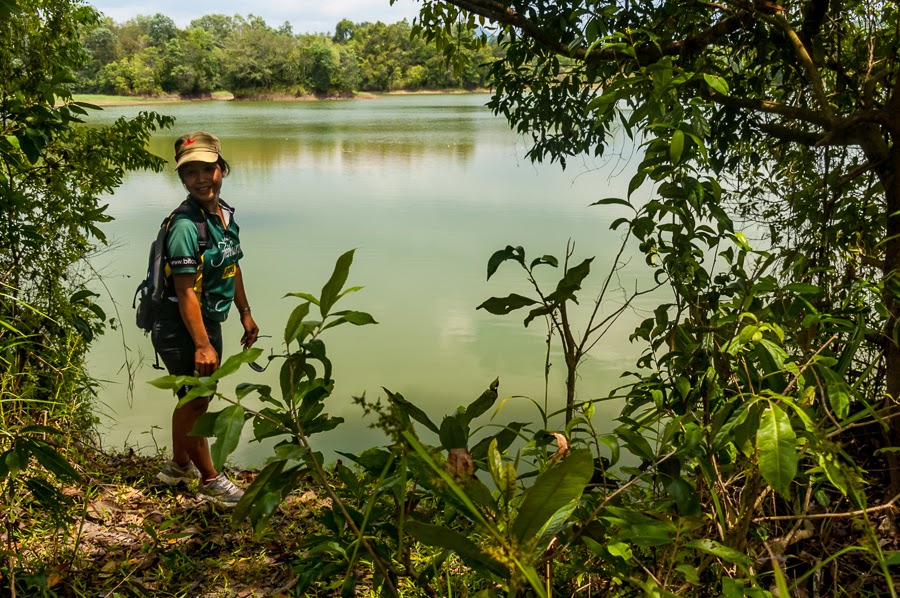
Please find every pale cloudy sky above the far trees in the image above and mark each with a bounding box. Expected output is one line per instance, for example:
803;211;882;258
86;0;420;33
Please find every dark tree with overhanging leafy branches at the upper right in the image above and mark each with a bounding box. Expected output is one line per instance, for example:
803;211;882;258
417;0;900;494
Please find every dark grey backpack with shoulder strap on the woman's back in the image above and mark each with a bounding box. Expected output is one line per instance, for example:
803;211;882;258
131;200;209;332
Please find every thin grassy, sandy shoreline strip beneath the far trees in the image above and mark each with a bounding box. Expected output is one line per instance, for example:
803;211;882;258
72;89;489;106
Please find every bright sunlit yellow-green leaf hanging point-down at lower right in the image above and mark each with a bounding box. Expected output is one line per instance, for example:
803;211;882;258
756;403;799;498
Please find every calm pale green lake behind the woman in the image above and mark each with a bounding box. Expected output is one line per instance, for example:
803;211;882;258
89;94;657;466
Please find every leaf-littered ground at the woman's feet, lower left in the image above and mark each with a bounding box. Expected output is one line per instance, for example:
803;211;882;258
13;451;328;598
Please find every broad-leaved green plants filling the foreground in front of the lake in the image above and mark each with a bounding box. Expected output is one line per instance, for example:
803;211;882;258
148;247;897;597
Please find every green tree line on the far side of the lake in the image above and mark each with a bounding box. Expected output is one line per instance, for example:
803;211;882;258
76;13;498;97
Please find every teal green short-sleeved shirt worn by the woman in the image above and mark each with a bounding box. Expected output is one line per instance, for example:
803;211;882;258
166;200;244;322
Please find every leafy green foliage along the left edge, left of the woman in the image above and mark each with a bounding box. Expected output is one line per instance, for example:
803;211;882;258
0;0;172;593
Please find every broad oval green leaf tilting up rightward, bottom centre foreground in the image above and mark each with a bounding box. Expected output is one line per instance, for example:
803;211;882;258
512;449;594;544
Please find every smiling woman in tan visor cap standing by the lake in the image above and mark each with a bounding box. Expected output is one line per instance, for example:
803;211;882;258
151;131;259;507
